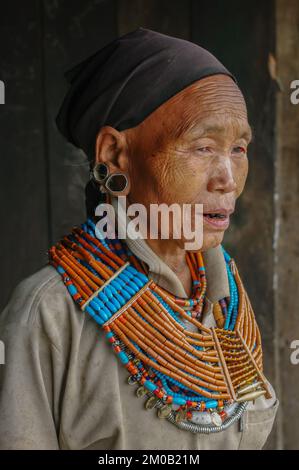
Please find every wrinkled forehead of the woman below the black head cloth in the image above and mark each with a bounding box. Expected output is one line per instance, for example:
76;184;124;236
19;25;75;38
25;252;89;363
129;74;252;148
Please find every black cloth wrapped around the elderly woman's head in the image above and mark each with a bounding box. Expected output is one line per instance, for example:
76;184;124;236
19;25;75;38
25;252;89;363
56;27;237;159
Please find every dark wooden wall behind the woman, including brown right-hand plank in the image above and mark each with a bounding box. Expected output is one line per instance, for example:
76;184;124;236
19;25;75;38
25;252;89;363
0;0;299;449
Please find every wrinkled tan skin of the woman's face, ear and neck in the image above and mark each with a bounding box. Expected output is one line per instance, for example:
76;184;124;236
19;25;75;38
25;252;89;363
95;74;251;295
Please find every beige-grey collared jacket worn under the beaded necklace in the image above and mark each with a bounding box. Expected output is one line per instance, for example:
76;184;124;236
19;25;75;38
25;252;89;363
0;233;278;450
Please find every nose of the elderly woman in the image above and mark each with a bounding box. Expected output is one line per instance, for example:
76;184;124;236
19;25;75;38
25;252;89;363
208;157;237;193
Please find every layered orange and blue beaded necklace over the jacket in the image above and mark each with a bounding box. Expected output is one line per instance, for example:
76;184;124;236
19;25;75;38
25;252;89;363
49;212;271;433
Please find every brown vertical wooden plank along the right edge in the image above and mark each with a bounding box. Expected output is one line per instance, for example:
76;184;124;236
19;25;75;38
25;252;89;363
275;0;299;449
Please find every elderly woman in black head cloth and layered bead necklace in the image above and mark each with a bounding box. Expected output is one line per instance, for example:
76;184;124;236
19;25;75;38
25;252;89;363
0;28;278;450
